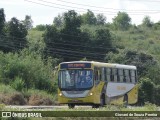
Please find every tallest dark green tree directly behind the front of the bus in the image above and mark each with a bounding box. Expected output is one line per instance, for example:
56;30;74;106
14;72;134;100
58;10;85;61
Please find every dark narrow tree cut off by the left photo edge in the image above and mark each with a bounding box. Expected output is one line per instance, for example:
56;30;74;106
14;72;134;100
0;8;5;34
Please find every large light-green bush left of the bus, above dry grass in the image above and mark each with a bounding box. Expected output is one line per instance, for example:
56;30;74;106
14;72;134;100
0;51;56;92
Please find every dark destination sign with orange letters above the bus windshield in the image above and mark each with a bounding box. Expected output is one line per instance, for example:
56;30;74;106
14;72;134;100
60;63;91;69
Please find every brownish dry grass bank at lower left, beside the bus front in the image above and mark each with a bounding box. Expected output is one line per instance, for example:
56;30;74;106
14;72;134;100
0;84;55;105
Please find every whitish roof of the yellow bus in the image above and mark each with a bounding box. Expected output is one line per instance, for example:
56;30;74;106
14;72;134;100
60;61;137;70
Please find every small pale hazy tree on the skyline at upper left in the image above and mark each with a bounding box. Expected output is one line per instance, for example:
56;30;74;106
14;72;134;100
23;15;33;30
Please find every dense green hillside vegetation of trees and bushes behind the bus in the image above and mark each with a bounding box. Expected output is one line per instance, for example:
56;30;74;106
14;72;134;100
0;9;160;105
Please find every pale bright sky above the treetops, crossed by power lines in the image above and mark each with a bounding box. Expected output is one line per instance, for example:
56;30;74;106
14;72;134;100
0;0;160;26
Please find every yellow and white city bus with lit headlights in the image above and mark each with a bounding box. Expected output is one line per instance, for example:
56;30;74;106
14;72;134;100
58;61;138;108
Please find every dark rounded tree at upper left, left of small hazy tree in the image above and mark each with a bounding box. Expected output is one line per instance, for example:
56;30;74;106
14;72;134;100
7;17;27;51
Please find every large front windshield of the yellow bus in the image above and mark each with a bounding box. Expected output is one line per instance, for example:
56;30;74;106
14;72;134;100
58;69;93;90
